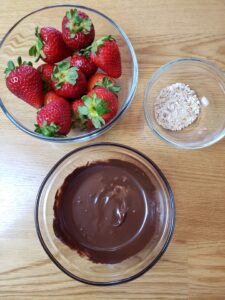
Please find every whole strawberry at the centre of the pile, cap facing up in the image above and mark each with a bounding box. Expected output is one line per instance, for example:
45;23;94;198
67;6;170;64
52;61;87;99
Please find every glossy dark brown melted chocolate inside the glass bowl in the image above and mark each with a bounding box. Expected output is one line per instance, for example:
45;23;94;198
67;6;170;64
53;159;159;264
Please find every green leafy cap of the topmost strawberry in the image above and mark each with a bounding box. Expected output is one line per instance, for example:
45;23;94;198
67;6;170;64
65;8;92;38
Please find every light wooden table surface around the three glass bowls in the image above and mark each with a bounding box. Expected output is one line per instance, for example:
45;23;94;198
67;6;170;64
0;0;225;300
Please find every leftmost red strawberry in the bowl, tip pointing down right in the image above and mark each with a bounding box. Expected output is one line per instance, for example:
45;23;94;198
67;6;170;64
5;57;44;108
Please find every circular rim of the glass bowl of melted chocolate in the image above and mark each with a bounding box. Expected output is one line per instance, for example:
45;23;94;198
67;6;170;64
34;142;175;286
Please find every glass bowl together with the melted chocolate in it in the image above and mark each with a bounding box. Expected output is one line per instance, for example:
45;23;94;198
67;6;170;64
35;143;175;285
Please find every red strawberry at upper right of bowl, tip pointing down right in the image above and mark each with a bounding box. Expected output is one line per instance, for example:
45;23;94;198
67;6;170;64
83;35;122;78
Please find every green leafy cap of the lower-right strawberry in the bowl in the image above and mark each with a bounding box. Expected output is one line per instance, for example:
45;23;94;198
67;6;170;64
78;92;110;128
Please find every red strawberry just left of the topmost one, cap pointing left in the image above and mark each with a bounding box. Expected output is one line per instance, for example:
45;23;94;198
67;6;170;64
29;27;72;64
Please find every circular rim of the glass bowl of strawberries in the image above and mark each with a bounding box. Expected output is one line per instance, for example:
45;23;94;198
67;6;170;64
0;4;138;143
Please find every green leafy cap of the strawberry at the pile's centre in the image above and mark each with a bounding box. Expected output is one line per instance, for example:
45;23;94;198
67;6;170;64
51;60;78;89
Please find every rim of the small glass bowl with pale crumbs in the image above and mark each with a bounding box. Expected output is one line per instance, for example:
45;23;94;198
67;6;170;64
143;57;225;150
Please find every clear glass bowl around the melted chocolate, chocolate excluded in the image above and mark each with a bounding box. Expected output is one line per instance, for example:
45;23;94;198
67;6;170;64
35;143;175;285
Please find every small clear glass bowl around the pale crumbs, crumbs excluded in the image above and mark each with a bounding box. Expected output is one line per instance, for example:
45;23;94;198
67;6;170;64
144;58;225;149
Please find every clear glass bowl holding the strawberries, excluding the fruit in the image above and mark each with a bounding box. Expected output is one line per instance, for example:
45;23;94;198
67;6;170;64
0;4;138;142
